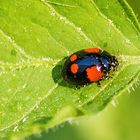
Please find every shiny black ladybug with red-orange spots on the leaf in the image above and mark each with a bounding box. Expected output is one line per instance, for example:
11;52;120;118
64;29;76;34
62;48;118;86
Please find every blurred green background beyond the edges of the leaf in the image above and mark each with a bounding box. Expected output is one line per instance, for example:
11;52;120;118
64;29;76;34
31;0;140;140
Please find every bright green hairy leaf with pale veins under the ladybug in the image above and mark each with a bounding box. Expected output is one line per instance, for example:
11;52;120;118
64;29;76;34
0;0;140;139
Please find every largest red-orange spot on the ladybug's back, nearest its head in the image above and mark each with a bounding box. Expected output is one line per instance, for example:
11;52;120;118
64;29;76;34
86;66;104;82
